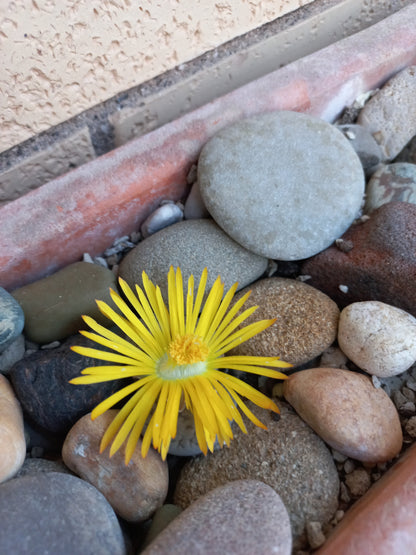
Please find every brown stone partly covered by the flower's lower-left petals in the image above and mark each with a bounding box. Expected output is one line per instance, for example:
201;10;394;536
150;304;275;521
62;410;169;522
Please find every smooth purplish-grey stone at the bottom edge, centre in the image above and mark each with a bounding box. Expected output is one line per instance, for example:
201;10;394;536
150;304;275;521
143;480;292;555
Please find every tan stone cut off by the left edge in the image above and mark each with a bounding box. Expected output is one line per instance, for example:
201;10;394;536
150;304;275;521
0;374;26;483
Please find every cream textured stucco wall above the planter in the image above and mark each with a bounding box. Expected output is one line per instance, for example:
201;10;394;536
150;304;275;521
0;0;313;152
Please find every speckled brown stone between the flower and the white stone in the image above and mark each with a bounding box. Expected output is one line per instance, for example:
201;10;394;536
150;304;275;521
232;277;339;365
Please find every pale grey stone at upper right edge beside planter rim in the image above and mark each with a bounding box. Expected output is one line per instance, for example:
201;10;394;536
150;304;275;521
358;66;416;160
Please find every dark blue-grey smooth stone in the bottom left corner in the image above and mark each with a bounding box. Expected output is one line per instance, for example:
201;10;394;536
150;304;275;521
0;472;127;555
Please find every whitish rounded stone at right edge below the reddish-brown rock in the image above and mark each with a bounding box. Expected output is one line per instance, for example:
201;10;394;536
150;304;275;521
338;301;416;378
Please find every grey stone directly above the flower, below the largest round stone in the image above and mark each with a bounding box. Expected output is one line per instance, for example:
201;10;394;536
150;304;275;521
119;220;267;298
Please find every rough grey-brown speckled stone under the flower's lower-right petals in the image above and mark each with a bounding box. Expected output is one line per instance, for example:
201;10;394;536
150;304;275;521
174;401;339;544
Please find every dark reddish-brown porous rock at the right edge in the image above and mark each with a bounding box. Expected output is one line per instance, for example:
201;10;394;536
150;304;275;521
301;202;416;316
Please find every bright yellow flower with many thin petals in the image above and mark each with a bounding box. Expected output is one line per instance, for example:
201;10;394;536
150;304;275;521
71;266;291;464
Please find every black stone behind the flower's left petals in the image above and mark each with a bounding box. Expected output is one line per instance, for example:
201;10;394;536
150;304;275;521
10;335;121;434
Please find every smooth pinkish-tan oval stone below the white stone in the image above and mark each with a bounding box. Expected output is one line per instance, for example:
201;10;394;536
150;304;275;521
284;368;403;462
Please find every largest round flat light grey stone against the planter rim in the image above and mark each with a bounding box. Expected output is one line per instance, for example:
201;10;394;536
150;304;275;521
198;112;364;260
